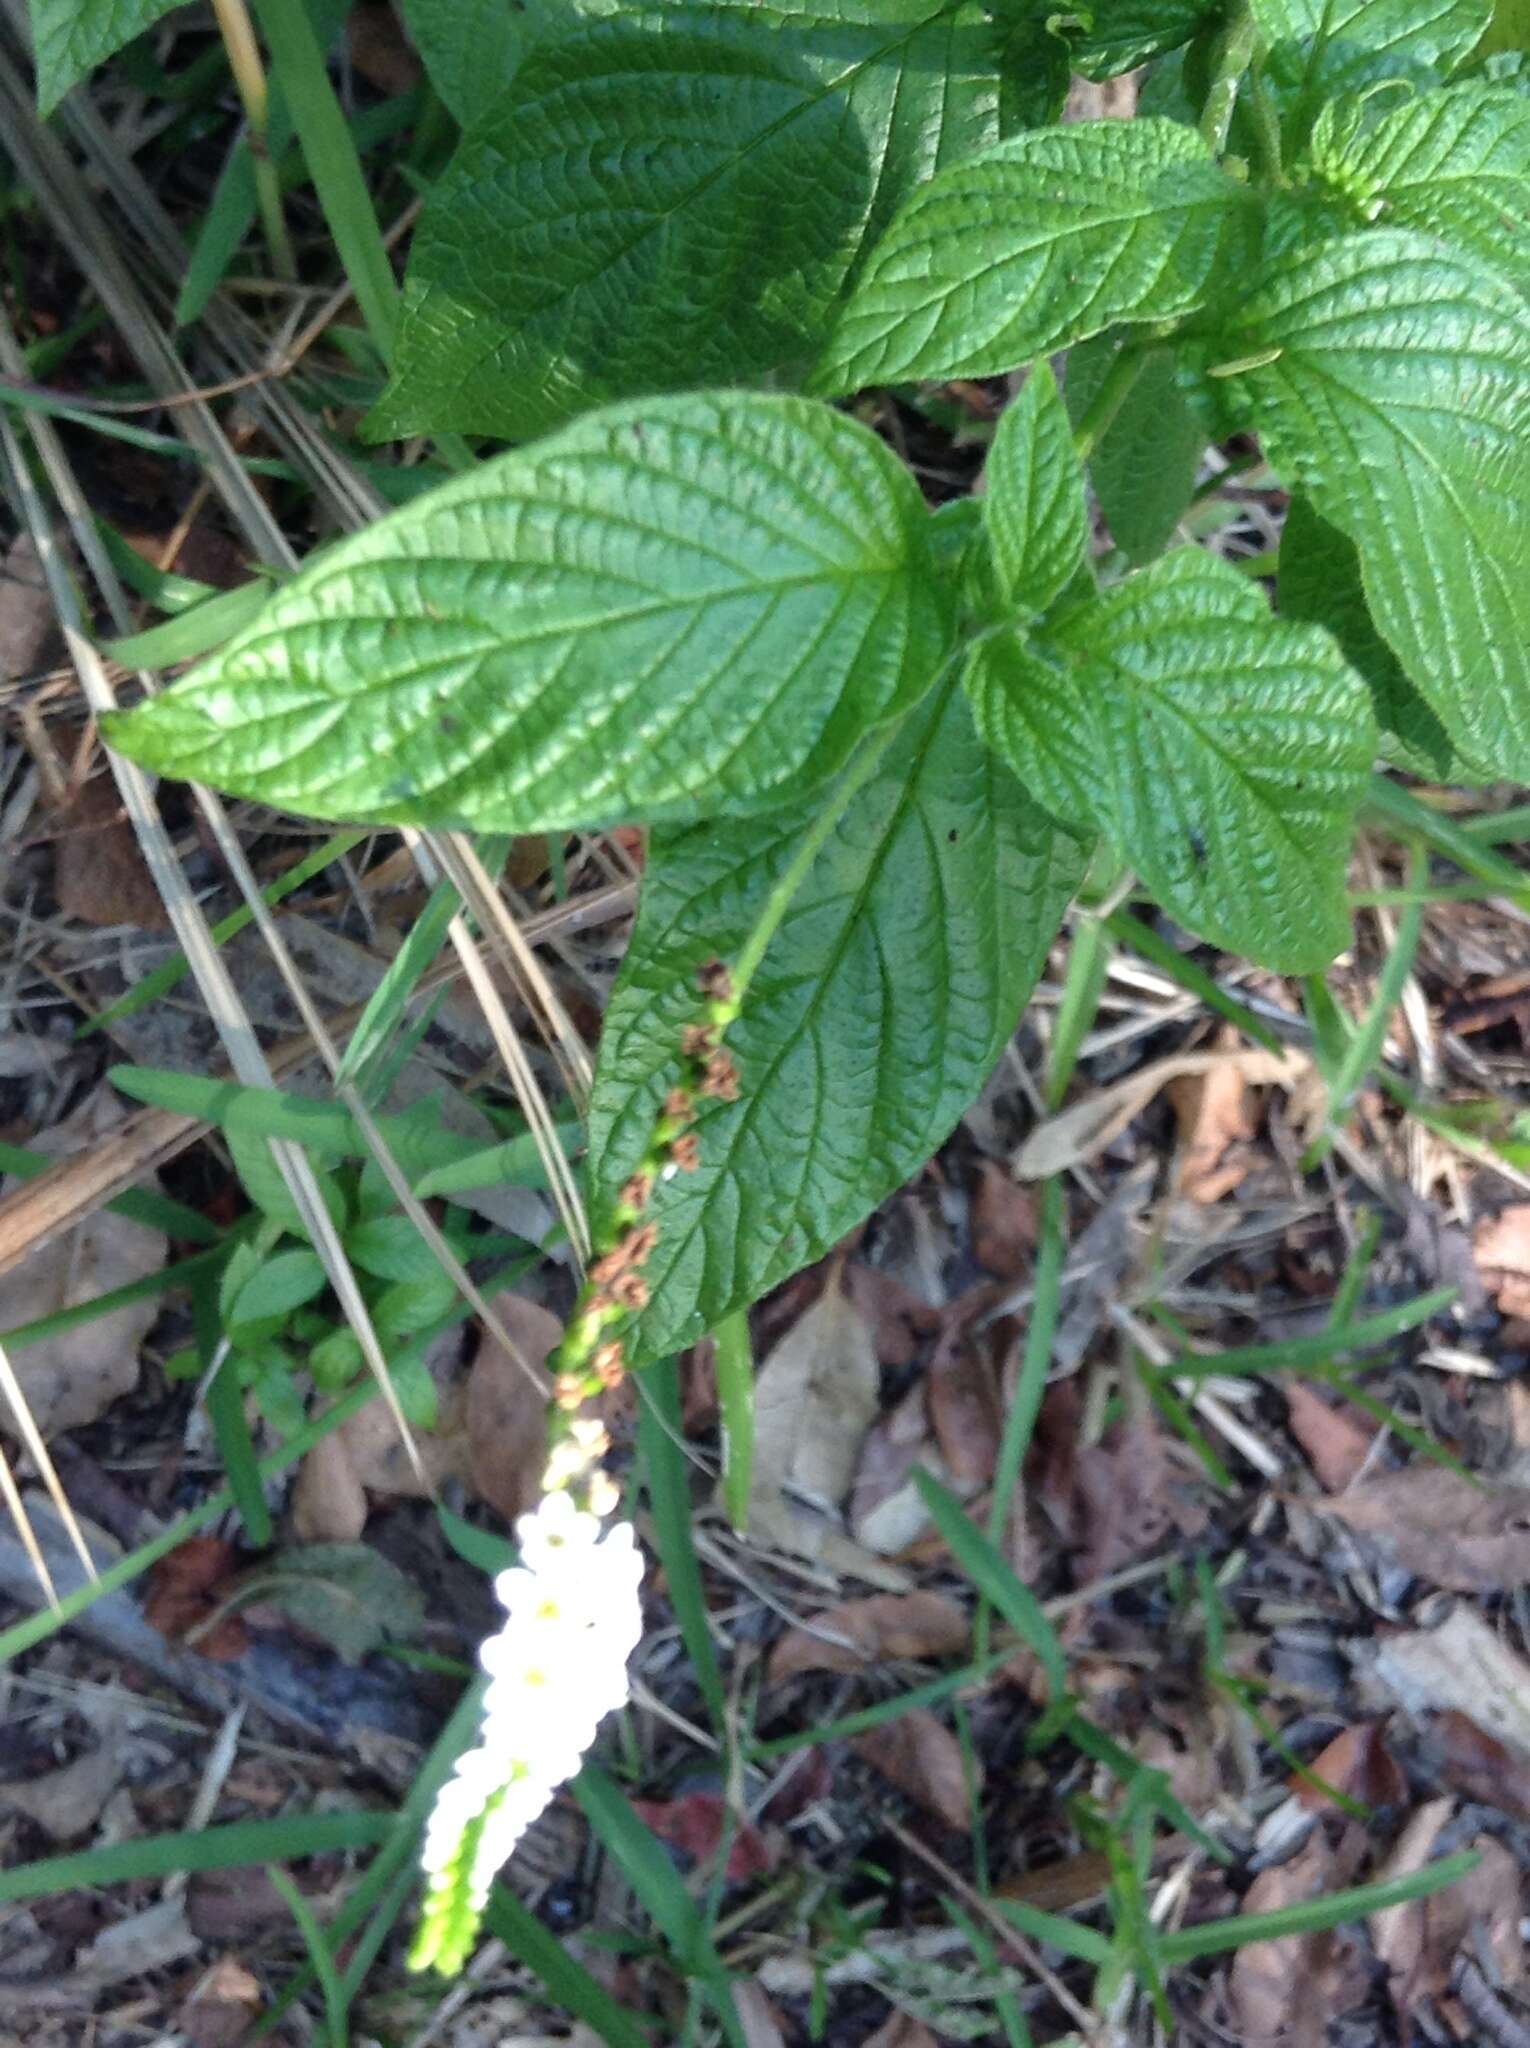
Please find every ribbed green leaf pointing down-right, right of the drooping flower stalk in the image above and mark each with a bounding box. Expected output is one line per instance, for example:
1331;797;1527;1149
967;549;1376;973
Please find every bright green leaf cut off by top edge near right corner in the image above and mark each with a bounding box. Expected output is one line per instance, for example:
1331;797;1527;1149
1253;0;1493;141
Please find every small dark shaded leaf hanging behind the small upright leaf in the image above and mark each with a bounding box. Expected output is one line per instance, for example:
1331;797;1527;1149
1067;336;1206;565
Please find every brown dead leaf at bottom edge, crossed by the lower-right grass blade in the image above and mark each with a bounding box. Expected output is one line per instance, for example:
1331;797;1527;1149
1227;1829;1368;2048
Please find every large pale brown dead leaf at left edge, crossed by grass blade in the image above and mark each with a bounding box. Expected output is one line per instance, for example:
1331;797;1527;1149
0;1090;168;1438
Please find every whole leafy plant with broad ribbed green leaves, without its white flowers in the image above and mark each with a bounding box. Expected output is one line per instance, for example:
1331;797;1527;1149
35;0;1530;2015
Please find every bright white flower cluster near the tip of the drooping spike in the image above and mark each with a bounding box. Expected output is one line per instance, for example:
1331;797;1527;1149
420;1493;643;1923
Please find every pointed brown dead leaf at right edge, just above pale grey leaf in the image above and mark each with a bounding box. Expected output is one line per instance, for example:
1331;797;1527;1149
1311;1464;1530;1593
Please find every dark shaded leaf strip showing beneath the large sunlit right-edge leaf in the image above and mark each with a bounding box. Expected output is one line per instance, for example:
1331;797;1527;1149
1280;498;1475;782
